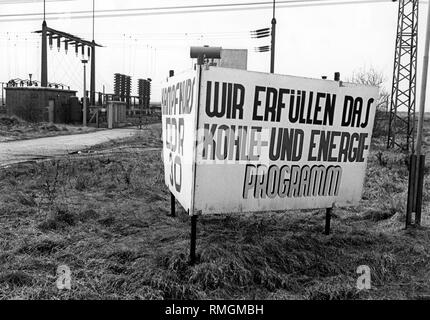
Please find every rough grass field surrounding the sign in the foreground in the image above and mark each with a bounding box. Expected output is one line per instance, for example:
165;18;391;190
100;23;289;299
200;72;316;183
0;121;430;299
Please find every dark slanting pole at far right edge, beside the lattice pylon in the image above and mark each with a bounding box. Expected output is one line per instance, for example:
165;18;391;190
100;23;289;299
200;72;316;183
415;0;430;226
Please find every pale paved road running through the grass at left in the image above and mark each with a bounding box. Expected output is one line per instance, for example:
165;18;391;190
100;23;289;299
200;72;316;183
0;128;140;167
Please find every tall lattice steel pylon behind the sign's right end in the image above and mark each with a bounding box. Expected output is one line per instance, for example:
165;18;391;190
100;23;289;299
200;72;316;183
387;0;418;153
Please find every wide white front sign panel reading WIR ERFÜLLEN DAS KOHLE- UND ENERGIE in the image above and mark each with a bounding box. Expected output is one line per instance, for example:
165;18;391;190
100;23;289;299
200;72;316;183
163;68;378;214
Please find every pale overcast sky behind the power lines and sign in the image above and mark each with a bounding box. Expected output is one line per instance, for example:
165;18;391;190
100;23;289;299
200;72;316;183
0;0;430;110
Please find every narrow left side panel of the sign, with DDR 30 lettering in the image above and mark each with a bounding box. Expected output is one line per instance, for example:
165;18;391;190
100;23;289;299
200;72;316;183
161;70;198;210
